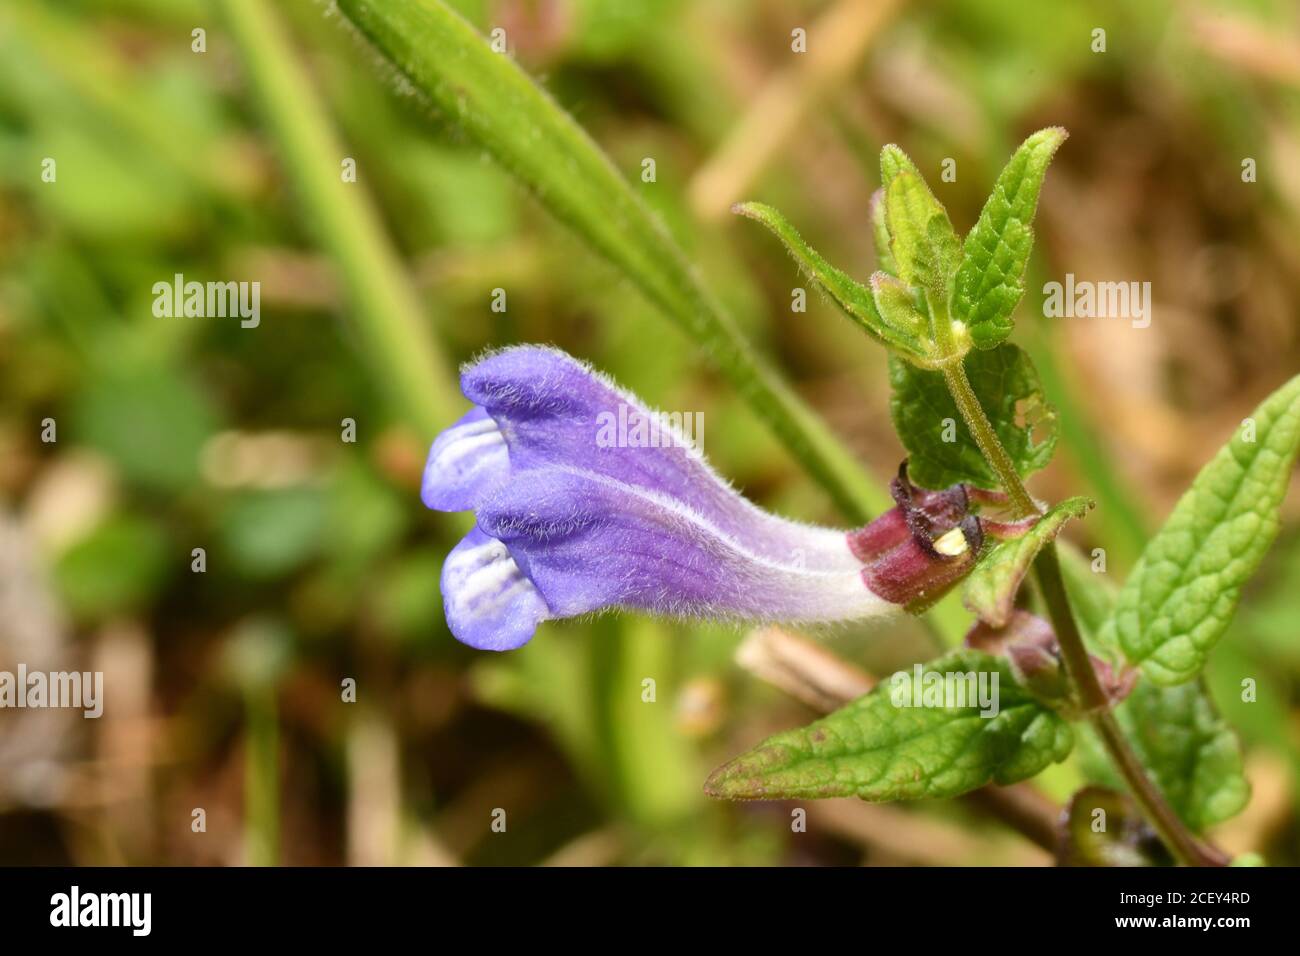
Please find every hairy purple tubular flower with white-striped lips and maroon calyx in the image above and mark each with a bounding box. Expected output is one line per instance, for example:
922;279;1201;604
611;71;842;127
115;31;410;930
421;346;979;650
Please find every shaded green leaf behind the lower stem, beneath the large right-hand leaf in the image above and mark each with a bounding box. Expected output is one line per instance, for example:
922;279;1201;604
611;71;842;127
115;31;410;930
1079;680;1251;831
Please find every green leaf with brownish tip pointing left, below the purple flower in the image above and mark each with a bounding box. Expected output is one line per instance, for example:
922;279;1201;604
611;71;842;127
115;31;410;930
705;650;1074;801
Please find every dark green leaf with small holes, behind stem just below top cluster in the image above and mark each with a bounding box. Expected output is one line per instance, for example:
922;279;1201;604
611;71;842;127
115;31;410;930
889;343;1057;489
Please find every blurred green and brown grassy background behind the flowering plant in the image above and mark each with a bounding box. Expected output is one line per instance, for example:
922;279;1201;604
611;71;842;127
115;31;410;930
0;0;1300;865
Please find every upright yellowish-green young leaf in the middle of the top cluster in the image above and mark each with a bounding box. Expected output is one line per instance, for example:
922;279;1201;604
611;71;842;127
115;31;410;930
885;170;961;295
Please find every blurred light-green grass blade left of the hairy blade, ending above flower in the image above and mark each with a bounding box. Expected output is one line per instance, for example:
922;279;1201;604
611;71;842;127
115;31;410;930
221;0;464;437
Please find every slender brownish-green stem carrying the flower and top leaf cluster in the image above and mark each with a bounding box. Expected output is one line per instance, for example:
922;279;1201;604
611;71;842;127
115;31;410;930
944;359;1227;866
